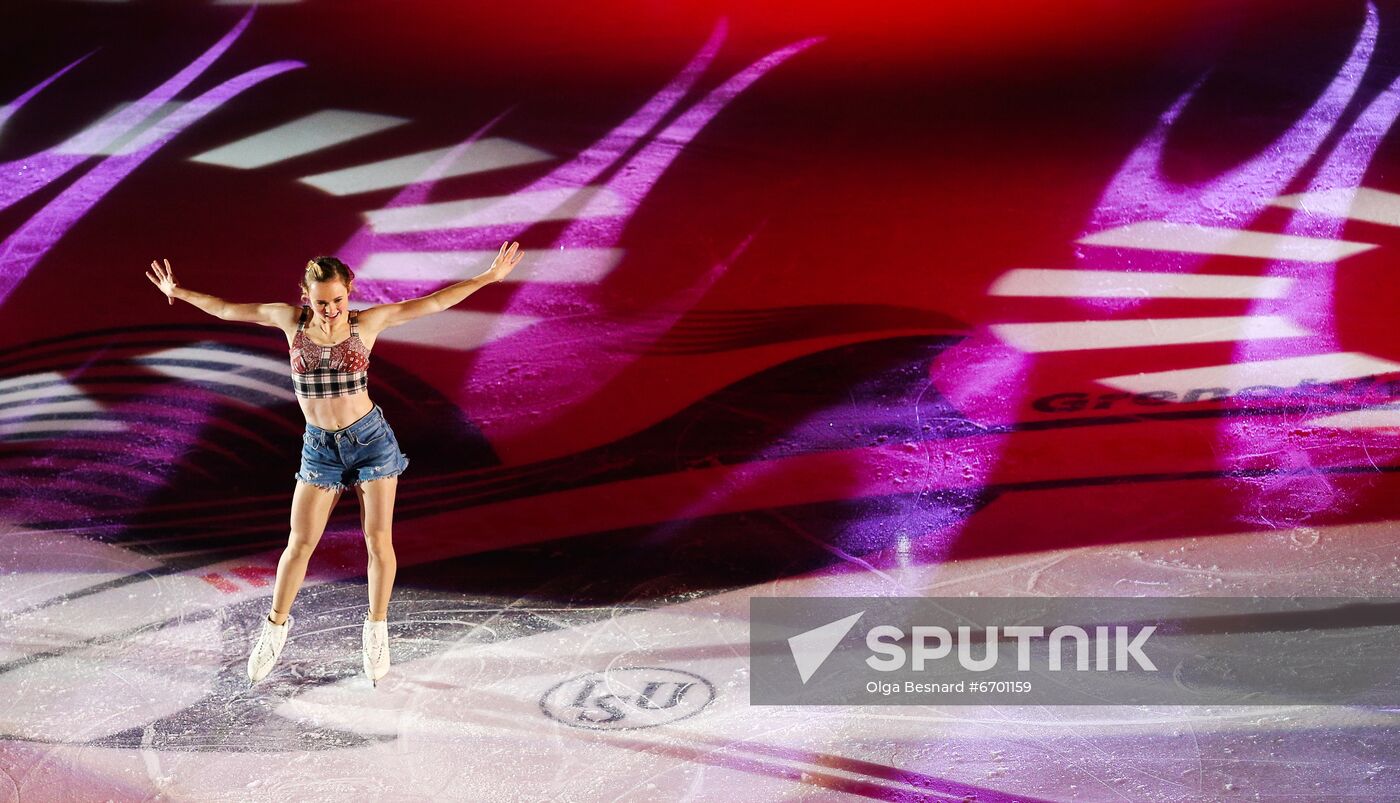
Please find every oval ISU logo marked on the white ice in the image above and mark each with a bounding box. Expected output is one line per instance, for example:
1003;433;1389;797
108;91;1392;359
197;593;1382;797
539;666;714;730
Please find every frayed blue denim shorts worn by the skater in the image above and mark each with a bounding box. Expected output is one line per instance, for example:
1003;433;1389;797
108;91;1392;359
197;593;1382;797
297;404;409;491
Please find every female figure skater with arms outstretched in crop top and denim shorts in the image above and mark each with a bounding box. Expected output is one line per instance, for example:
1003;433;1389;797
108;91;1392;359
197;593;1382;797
146;242;522;685
